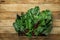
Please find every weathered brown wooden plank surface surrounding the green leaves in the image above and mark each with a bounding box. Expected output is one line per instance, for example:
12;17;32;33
0;0;60;40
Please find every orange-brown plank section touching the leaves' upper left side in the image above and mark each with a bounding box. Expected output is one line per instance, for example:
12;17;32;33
0;12;21;20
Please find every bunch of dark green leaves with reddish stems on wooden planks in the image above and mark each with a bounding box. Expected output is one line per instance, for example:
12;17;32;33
13;6;52;37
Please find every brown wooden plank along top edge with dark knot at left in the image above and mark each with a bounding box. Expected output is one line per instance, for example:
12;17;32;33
0;0;60;4
